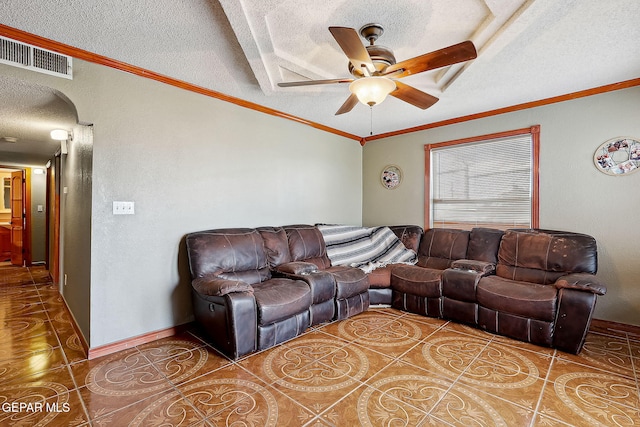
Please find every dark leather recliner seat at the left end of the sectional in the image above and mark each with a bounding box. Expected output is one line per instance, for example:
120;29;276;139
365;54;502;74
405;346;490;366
186;228;312;359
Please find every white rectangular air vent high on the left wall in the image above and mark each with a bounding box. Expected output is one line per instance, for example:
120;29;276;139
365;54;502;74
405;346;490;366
0;36;73;79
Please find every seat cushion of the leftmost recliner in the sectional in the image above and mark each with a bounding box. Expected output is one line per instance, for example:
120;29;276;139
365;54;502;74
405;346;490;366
253;278;311;325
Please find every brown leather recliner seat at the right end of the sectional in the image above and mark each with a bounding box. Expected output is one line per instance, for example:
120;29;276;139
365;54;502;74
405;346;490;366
476;229;606;354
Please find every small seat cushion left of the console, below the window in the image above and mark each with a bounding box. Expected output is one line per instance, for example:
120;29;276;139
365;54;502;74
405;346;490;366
391;265;442;298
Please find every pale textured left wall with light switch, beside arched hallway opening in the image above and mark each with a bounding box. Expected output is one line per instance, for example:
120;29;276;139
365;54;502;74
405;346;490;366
0;61;362;347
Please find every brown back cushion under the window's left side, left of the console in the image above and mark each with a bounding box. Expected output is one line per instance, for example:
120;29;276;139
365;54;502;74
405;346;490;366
418;228;469;270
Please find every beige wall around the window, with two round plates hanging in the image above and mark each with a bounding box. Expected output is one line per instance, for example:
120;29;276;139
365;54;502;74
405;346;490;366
363;87;640;325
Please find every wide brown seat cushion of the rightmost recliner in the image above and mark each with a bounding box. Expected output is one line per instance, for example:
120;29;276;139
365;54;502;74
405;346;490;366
476;276;558;322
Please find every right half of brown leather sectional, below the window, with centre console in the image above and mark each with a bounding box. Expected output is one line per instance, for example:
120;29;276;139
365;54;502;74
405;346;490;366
391;228;606;354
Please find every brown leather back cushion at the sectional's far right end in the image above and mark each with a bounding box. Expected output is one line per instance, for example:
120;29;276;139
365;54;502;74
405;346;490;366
496;229;598;285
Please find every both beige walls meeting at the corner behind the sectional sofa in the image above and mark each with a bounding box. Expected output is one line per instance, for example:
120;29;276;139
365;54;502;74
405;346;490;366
0;56;640;347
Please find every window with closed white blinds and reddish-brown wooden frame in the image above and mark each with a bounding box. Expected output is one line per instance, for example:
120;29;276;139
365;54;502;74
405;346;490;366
425;126;540;230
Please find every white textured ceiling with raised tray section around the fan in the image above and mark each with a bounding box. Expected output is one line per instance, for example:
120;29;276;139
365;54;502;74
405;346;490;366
0;0;640;162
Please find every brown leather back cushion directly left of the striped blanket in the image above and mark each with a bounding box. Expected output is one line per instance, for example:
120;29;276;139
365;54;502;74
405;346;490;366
283;225;331;270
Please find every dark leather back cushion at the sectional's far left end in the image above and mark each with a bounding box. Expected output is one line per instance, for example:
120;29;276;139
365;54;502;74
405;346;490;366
186;228;271;285
